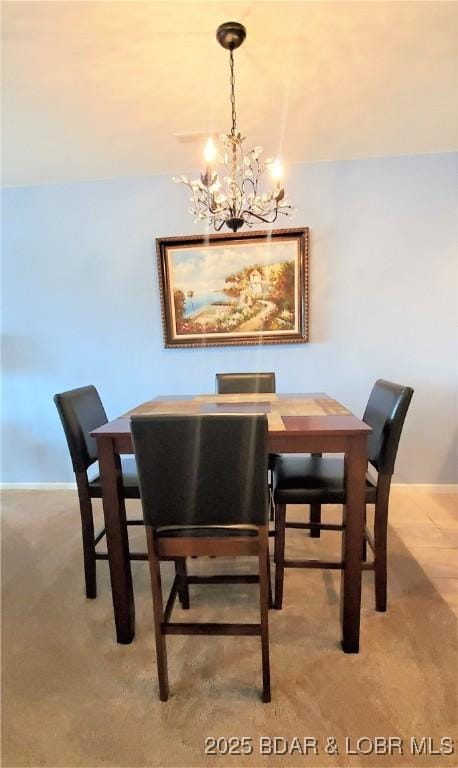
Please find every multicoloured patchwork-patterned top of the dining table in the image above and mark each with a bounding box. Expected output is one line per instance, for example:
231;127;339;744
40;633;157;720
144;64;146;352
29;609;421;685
91;392;371;439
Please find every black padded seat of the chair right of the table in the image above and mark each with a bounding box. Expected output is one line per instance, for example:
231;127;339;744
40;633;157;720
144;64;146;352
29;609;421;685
273;454;376;504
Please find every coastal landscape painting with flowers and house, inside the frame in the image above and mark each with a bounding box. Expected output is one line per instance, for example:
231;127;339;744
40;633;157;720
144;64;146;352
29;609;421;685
169;240;298;335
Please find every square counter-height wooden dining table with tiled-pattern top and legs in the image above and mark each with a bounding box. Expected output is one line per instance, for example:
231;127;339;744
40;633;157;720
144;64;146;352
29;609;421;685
91;393;371;653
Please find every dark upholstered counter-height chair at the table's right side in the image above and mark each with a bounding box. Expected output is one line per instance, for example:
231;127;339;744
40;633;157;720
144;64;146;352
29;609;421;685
273;379;413;611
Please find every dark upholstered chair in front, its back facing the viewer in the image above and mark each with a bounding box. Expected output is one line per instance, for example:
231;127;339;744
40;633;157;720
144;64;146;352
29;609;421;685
131;414;270;702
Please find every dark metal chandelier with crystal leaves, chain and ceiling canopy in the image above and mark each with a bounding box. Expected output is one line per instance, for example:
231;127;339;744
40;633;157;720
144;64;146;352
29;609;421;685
173;21;293;232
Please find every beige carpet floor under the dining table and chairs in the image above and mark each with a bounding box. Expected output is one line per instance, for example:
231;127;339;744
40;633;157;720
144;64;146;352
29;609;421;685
2;491;457;768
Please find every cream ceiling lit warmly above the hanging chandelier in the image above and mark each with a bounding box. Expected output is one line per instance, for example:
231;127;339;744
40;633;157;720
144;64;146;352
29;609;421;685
2;0;458;185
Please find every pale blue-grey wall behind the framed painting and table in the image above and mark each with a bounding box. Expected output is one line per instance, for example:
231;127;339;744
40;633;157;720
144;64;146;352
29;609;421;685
2;154;457;483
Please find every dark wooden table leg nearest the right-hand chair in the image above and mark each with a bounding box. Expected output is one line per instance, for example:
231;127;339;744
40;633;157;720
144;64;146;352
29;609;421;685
340;435;367;653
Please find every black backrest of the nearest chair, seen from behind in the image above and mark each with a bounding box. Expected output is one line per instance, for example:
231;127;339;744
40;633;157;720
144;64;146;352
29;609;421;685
131;414;268;527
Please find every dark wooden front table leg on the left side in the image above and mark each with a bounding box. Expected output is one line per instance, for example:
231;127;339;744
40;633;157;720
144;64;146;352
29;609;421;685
97;437;135;644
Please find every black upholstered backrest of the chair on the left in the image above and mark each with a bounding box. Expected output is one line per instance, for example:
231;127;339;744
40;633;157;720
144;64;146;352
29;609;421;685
54;386;108;472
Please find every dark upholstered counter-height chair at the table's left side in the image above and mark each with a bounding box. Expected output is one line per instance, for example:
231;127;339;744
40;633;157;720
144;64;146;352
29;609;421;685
54;386;187;608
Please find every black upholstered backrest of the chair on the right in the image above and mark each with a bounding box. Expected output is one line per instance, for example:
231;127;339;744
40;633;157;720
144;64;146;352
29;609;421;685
363;379;413;475
